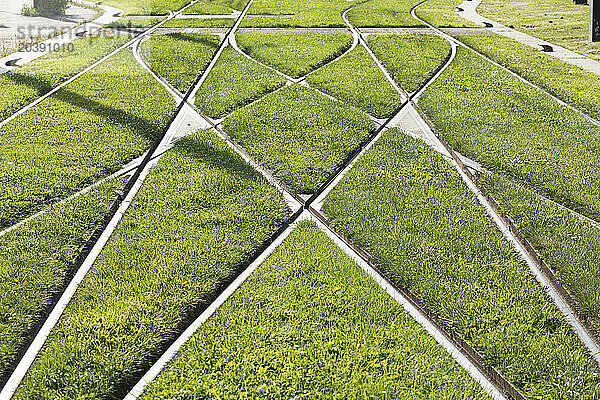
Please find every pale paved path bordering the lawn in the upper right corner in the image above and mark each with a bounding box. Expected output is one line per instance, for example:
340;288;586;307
457;0;600;75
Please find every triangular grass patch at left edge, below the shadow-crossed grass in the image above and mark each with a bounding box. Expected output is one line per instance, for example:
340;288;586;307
0;178;124;379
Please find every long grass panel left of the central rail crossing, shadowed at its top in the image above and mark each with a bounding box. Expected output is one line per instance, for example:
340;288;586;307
15;131;288;400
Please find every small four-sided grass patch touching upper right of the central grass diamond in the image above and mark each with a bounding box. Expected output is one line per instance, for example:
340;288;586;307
307;46;402;118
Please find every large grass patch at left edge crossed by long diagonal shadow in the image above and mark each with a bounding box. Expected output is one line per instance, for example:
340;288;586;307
0;50;175;231
